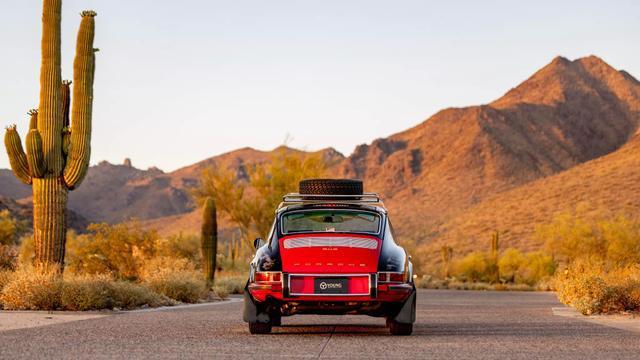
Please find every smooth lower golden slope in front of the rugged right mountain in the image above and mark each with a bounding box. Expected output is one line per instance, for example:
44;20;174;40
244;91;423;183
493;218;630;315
426;132;640;252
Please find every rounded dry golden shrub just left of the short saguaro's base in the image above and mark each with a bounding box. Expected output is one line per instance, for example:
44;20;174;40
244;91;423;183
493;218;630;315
141;257;207;303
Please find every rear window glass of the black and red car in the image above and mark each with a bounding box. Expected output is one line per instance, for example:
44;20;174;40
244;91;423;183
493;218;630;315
282;210;380;234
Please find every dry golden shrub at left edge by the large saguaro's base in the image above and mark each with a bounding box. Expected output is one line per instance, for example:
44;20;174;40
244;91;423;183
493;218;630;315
0;268;62;310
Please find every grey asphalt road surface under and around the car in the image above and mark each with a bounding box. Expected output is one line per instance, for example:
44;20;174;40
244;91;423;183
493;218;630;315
0;290;640;359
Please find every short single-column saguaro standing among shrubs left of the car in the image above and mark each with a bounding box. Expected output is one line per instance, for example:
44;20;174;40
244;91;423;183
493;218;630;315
200;197;218;286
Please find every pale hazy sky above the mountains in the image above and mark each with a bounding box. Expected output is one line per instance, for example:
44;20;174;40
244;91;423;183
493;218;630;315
0;0;640;170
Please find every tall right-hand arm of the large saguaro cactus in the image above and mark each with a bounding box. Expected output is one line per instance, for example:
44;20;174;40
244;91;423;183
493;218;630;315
64;11;96;190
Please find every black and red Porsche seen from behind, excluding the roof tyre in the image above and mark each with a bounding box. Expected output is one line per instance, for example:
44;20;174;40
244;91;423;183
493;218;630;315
245;181;415;334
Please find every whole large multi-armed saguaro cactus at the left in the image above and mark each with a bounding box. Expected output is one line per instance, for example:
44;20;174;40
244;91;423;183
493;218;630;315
5;0;97;266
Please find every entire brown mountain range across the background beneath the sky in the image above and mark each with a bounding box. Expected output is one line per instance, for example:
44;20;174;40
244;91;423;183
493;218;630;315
0;56;640;252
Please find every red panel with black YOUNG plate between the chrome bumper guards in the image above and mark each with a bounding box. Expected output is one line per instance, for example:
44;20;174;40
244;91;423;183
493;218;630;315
285;274;371;296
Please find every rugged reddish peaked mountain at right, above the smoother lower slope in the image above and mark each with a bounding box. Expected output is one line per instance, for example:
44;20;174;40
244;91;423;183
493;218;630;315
341;57;640;239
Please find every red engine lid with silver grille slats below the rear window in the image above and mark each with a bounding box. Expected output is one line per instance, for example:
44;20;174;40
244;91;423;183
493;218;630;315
279;233;381;274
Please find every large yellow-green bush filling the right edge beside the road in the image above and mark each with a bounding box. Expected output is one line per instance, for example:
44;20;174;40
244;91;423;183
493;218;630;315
536;212;640;314
